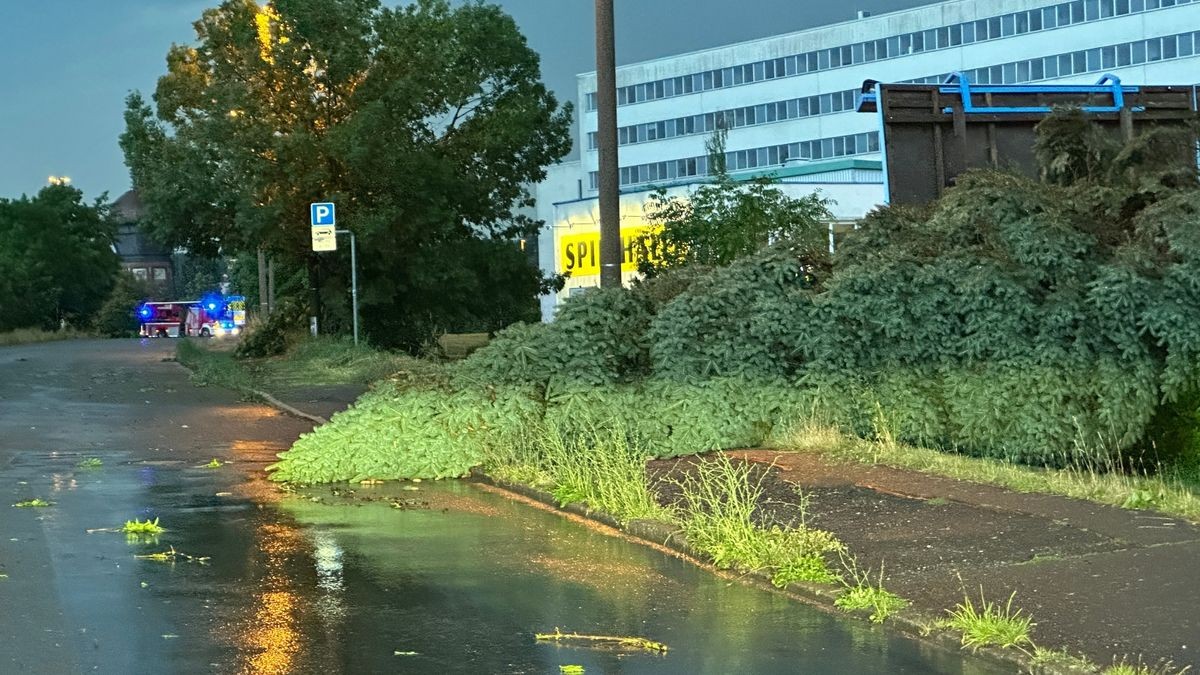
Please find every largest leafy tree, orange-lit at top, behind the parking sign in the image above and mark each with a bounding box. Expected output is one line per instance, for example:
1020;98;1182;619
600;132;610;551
121;0;570;346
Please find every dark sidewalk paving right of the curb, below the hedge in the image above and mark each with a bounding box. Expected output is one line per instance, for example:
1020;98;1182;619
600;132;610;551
731;450;1200;670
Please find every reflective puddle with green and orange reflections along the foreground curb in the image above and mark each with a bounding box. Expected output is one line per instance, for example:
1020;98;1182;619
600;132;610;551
4;458;1008;675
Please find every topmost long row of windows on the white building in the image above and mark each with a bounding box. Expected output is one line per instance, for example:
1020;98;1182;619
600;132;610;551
586;0;1200;110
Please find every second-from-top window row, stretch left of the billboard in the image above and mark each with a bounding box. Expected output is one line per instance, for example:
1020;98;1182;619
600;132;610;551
588;89;858;150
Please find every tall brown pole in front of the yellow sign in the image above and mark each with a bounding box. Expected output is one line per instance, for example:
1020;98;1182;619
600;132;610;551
596;0;623;288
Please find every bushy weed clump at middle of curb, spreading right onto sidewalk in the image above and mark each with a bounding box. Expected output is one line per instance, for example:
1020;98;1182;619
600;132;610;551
676;454;844;589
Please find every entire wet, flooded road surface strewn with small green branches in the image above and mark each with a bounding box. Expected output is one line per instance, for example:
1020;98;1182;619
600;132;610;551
0;342;992;674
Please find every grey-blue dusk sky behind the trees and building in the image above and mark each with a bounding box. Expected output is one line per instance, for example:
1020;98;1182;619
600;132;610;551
0;0;931;199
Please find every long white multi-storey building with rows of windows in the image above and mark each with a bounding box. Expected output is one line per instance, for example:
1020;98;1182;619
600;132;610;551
536;0;1200;318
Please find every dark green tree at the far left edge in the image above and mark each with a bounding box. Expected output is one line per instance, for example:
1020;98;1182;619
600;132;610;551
0;185;119;330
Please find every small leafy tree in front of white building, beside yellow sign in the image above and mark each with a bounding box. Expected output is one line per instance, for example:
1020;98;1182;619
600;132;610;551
642;127;833;274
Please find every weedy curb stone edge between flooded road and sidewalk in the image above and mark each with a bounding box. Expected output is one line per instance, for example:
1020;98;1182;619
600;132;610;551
470;467;1098;675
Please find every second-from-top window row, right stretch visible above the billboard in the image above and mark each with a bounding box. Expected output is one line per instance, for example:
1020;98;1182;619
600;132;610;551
910;31;1200;84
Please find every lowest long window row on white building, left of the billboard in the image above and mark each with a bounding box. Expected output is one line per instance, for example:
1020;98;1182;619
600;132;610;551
588;131;880;190
